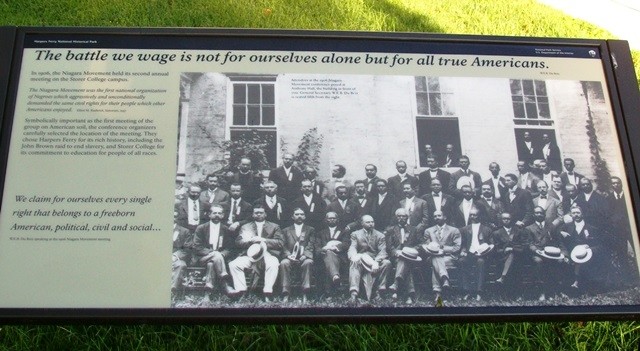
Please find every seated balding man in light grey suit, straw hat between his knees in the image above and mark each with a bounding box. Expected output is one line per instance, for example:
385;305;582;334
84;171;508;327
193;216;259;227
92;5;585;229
347;215;391;302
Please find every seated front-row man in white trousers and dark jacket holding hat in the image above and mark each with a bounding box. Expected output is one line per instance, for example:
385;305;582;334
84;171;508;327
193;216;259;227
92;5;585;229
229;207;283;302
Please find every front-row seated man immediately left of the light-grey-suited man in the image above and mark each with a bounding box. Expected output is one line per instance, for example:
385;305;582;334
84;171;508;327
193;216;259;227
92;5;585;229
314;211;350;294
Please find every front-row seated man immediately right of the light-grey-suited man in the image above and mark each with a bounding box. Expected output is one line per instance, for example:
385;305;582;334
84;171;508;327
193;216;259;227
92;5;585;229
384;208;422;304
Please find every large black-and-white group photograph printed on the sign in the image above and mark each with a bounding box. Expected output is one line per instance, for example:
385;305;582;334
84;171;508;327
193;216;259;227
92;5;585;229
167;72;640;308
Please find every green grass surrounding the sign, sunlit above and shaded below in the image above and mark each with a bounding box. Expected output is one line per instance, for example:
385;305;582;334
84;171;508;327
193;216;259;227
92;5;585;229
0;0;640;350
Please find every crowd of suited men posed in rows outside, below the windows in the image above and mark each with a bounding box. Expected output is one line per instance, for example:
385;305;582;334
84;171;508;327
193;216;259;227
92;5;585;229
172;154;638;303
